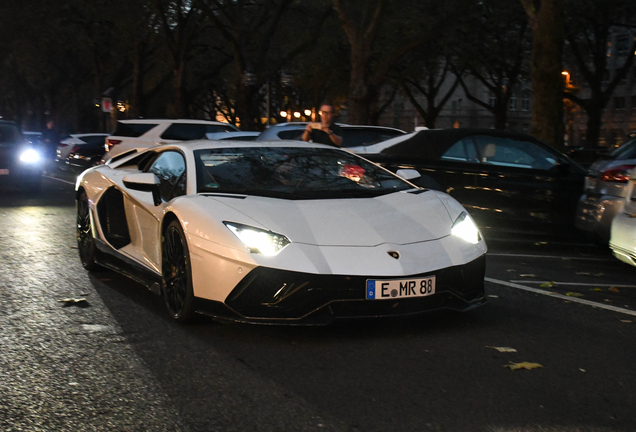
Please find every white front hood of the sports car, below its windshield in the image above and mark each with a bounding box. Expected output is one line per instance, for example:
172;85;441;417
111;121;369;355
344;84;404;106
207;191;452;246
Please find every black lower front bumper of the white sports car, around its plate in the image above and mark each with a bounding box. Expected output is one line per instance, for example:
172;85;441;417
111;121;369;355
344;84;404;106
196;255;486;325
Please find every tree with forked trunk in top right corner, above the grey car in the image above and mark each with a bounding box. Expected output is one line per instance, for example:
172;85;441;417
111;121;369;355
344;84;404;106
565;0;636;148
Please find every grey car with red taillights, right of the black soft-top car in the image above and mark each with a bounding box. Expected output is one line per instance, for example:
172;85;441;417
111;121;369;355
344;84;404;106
575;139;636;245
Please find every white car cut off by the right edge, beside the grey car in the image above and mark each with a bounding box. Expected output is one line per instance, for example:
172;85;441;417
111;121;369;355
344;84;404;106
609;168;636;266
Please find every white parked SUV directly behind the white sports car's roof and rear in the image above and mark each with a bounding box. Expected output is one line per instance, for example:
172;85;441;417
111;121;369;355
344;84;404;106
103;119;239;161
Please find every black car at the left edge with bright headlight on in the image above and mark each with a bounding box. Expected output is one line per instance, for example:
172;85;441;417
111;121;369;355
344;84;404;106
0;120;45;190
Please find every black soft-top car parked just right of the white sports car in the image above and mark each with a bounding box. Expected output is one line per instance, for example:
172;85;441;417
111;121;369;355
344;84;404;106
365;129;585;238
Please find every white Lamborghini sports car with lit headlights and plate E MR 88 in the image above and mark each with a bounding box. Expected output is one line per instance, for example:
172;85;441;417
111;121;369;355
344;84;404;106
76;141;486;324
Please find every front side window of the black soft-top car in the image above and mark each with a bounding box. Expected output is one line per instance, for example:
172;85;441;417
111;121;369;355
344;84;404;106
472;135;557;170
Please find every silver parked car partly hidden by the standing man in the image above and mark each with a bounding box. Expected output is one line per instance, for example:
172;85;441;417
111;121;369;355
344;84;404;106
257;122;406;148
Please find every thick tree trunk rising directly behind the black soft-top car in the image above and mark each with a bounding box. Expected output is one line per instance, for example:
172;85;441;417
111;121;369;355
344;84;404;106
520;0;565;149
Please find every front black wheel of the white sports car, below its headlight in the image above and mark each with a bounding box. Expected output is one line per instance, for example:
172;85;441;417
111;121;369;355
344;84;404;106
161;221;194;324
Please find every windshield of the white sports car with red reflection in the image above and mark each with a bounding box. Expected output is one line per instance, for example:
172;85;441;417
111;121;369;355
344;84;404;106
194;147;413;199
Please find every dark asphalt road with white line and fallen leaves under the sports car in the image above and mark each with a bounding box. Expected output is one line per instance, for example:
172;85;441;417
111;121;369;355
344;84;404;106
0;173;636;431
